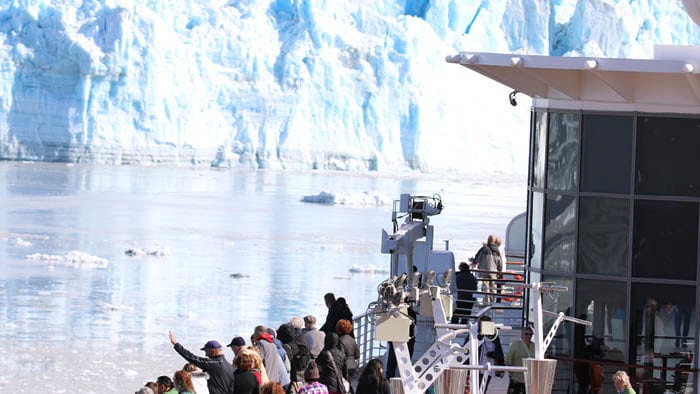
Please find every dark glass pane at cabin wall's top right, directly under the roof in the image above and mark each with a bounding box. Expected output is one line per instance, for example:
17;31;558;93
635;116;700;197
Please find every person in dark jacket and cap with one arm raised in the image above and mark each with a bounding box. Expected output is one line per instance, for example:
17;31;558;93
168;331;233;394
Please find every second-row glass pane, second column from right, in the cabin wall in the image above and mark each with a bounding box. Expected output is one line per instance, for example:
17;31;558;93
577;197;630;276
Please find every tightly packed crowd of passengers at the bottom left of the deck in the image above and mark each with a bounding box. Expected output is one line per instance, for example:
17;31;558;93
136;293;384;394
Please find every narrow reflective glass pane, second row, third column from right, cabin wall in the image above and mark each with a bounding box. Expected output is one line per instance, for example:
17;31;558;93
543;194;576;272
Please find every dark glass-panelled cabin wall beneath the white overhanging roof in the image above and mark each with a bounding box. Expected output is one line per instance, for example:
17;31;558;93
526;107;700;393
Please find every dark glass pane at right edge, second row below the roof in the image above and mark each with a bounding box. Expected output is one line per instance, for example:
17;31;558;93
632;200;698;280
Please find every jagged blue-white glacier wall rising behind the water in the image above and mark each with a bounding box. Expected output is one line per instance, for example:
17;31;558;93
0;0;700;174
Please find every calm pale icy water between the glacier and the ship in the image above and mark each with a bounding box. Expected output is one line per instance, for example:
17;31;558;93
0;162;525;393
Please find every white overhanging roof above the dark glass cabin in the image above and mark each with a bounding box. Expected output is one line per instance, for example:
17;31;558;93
447;46;700;113
